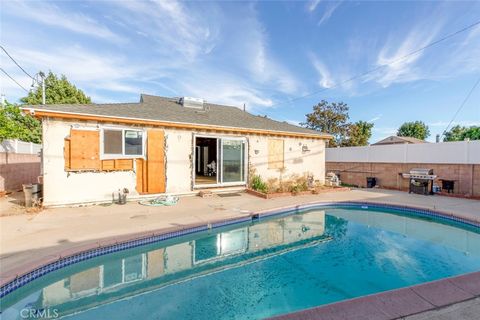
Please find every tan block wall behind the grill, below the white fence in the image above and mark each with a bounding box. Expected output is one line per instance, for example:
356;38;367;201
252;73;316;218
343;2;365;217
325;161;480;197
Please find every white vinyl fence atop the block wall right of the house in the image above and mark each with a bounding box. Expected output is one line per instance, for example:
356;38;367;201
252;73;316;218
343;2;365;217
325;141;480;164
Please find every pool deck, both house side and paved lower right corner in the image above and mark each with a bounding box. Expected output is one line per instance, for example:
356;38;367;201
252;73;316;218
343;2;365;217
0;189;480;320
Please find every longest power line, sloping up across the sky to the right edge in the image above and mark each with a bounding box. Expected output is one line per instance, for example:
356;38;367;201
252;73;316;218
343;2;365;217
271;20;480;107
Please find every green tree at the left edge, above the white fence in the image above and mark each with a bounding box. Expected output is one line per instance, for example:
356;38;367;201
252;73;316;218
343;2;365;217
0;102;42;143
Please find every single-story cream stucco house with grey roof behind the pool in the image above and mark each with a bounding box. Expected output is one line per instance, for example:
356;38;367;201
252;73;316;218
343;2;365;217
23;94;331;206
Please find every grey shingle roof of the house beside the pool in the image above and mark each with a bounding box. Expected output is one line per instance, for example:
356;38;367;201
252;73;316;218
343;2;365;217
22;94;331;139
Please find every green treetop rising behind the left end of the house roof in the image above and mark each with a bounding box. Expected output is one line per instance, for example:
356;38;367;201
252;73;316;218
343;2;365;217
20;71;92;105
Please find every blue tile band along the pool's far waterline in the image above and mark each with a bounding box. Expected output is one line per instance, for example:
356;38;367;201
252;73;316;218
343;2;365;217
0;201;480;298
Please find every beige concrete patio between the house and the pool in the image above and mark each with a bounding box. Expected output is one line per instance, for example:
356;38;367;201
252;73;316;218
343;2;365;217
0;189;480;319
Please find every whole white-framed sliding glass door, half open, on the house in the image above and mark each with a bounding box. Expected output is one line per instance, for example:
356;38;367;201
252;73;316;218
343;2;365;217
194;136;246;186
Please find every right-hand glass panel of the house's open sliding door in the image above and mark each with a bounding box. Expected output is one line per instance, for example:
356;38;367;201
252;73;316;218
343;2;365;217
221;139;245;183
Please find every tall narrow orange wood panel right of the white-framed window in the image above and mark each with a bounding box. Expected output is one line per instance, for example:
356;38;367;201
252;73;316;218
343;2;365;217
146;129;165;193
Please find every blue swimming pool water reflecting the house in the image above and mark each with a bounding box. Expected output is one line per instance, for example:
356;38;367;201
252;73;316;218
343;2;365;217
1;209;480;320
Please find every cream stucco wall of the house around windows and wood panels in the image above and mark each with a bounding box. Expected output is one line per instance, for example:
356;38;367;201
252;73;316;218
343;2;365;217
43;118;325;206
